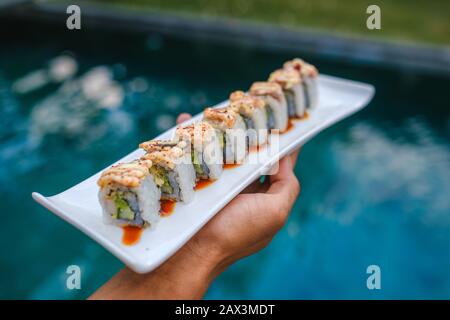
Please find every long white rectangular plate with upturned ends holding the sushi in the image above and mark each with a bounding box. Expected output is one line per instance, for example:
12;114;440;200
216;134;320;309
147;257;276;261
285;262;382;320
33;75;375;273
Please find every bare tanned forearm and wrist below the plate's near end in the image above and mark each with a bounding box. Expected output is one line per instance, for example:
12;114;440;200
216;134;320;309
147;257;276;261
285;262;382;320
89;242;221;299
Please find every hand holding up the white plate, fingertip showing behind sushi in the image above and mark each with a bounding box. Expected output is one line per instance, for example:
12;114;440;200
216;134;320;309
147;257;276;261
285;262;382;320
177;113;300;274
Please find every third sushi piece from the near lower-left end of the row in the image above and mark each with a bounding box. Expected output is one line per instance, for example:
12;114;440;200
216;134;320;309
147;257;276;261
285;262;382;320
174;121;223;180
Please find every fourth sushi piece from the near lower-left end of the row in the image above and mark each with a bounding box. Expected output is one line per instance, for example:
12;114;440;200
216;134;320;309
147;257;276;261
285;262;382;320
203;107;248;164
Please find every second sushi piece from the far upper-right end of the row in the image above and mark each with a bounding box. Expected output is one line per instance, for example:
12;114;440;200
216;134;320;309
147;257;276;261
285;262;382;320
269;69;306;118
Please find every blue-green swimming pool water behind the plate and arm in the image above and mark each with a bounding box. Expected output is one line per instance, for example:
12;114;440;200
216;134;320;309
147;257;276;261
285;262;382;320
0;17;450;299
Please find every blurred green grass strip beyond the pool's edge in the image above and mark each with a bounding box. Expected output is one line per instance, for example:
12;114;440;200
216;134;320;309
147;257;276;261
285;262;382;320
87;0;450;45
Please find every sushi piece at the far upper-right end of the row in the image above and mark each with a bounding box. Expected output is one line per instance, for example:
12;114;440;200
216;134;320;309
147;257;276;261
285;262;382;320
283;58;319;109
